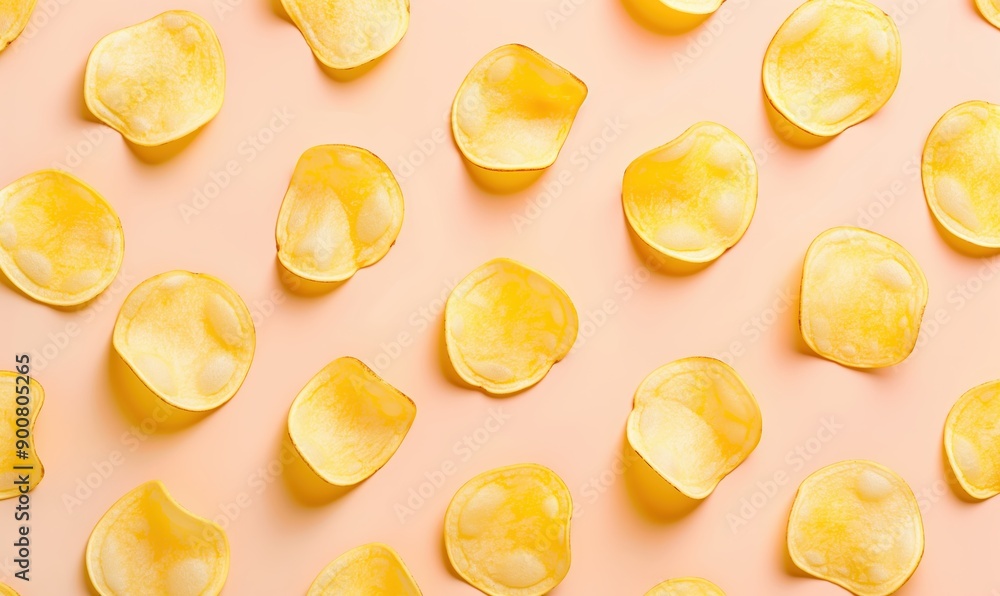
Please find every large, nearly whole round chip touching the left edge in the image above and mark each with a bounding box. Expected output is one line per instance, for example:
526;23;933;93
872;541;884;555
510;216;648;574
0;170;125;306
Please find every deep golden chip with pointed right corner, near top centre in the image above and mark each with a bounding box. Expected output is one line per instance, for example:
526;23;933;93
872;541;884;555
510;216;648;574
451;44;587;171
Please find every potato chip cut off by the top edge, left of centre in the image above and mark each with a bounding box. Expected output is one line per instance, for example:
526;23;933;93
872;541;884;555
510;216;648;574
281;0;410;70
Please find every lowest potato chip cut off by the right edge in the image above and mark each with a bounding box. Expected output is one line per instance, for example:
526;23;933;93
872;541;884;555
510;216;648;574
944;381;1000;499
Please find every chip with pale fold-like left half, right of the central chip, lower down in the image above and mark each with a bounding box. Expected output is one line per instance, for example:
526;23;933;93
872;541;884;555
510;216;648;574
626;357;761;499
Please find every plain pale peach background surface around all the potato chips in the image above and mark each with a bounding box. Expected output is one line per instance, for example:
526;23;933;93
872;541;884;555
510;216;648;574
0;0;1000;596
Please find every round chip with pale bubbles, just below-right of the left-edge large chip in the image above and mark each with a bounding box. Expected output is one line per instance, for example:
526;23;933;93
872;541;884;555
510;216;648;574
112;271;256;412
